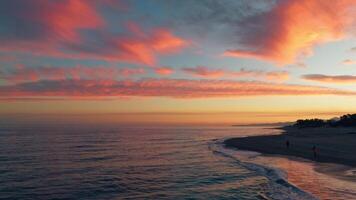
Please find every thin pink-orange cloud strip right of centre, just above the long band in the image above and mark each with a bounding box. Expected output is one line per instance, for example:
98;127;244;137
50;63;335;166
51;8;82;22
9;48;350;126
182;66;289;81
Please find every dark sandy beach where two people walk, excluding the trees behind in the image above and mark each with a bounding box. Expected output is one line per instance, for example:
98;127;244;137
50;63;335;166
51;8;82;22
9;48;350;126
223;127;356;181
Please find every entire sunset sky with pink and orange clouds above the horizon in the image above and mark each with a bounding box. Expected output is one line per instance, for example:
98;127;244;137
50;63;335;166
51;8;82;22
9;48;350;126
0;0;356;124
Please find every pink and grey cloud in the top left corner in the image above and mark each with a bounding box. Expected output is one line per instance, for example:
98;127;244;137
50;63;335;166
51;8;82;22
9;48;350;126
1;0;105;45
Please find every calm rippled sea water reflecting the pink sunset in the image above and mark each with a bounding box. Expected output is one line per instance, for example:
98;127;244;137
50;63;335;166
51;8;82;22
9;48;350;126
0;126;356;199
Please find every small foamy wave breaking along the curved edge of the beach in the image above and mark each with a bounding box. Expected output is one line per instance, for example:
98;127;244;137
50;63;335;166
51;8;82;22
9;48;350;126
209;139;317;200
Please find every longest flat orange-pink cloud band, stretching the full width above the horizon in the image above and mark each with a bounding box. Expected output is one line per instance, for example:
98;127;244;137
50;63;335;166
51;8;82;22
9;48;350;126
0;79;356;99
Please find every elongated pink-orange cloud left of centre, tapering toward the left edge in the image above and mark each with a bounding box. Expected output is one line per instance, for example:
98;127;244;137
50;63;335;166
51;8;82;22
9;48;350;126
11;28;189;66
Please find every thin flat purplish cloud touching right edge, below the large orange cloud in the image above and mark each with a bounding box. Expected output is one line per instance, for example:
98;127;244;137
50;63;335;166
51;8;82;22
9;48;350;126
302;74;356;84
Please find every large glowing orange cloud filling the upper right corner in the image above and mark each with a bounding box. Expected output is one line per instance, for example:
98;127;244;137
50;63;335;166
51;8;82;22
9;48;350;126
223;0;356;65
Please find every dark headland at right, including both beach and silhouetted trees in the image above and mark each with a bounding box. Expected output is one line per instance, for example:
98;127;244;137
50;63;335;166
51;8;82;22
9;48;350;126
224;114;356;167
